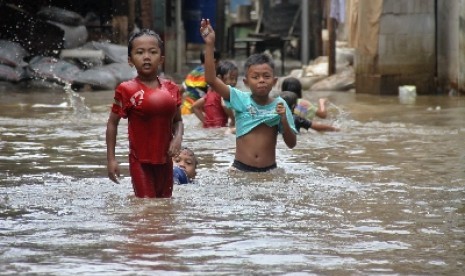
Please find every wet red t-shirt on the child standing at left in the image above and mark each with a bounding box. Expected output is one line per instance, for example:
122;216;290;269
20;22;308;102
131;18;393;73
112;78;181;164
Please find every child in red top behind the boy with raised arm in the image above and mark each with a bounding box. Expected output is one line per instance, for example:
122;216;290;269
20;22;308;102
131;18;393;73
192;61;239;128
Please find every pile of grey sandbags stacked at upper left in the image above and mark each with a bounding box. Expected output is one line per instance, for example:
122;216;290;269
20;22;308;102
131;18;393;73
0;6;136;90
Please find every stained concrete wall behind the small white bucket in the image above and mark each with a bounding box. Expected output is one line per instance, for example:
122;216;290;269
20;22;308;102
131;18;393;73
356;0;436;94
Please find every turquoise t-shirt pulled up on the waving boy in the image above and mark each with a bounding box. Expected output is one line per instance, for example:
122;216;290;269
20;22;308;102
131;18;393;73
225;87;297;137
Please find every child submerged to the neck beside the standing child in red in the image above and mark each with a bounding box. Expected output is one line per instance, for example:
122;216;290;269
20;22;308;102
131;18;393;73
173;148;199;184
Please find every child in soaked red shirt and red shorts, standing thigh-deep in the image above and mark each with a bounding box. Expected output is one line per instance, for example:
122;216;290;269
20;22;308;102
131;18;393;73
106;29;183;198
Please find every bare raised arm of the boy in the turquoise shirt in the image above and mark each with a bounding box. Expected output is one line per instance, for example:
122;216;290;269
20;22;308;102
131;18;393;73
200;19;229;100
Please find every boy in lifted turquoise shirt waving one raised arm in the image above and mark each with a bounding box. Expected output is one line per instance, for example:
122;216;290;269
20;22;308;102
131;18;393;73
200;19;297;172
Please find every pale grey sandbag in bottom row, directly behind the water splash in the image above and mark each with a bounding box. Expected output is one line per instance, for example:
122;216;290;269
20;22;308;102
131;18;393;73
28;56;82;83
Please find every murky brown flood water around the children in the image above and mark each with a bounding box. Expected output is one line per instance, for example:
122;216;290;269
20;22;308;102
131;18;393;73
0;83;465;275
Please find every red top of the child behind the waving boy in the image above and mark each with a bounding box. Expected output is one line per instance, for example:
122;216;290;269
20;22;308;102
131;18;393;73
203;89;228;128
